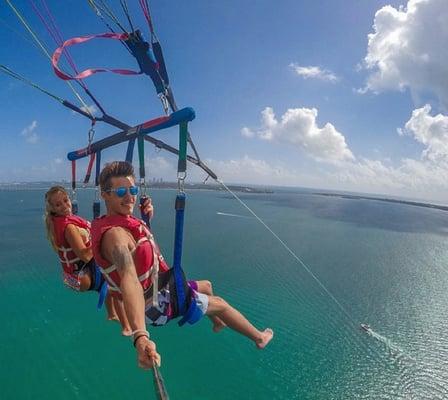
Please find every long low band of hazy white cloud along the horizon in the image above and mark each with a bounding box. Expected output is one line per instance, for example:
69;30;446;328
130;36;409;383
189;155;448;201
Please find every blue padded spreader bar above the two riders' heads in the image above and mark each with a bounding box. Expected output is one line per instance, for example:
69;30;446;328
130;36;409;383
67;107;196;161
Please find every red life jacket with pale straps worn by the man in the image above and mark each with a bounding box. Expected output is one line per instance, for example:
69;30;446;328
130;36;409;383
92;215;169;297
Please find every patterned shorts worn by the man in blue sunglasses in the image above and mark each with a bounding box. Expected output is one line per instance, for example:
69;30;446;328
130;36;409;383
145;281;208;326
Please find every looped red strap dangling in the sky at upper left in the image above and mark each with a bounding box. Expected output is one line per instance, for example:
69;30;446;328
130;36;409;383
51;32;141;81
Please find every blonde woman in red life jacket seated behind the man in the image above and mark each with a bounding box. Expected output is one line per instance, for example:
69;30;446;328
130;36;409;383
45;186;132;336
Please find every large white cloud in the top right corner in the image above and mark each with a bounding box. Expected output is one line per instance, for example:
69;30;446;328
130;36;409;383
361;0;448;106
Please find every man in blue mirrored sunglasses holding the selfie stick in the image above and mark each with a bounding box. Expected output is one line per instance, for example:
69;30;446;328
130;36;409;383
92;161;273;368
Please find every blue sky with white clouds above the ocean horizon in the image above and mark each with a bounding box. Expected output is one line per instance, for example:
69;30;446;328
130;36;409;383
0;0;448;203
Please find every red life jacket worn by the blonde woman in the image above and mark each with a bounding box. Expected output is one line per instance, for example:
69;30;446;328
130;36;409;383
52;215;91;290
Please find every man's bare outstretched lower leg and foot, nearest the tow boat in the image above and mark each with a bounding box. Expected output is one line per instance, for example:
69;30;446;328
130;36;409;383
206;296;274;349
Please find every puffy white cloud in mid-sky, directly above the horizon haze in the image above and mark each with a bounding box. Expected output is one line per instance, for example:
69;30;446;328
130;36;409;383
241;107;354;162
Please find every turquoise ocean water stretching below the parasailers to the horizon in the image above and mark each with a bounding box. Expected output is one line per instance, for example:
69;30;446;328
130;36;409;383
0;189;448;400
